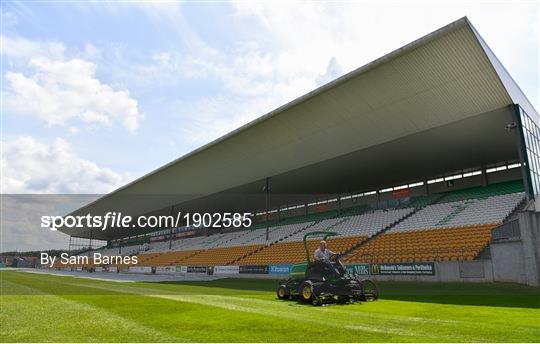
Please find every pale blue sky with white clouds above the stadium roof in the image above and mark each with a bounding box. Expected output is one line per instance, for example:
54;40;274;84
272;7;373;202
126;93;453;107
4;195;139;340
0;1;540;253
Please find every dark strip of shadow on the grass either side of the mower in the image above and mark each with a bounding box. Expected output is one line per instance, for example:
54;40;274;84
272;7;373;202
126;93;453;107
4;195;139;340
156;278;540;309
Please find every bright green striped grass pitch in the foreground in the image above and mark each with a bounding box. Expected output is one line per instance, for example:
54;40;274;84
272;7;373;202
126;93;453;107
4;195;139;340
0;271;540;342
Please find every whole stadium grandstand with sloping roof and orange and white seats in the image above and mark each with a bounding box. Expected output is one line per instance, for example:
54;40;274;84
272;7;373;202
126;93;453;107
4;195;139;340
52;18;540;285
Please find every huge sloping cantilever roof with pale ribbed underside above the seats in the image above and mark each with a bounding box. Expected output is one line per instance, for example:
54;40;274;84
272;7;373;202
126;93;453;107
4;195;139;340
62;18;538;240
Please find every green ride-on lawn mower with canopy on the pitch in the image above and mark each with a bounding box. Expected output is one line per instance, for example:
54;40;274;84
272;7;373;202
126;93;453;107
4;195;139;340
277;232;379;306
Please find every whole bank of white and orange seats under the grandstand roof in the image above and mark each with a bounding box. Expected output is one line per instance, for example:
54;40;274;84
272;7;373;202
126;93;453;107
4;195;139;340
57;181;525;266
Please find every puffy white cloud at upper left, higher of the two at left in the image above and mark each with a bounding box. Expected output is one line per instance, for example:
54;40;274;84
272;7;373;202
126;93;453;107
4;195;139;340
5;58;141;132
